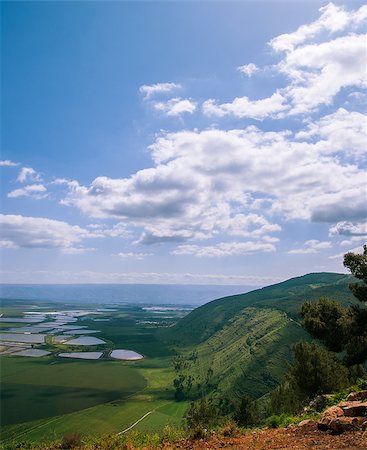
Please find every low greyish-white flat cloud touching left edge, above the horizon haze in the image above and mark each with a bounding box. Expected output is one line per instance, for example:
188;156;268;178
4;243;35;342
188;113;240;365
0;214;95;252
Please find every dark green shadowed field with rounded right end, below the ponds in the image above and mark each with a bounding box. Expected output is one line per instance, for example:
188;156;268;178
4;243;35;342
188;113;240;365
0;357;146;425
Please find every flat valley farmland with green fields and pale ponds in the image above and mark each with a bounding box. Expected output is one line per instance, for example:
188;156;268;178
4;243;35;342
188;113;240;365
0;301;190;443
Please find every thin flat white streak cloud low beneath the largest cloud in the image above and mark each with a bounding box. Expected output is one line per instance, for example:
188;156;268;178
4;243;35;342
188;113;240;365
172;241;275;258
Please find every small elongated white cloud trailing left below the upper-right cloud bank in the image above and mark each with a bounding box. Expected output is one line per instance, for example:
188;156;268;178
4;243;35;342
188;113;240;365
202;92;287;120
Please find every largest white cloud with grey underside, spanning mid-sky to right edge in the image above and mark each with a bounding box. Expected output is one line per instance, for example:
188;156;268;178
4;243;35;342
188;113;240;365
63;123;366;244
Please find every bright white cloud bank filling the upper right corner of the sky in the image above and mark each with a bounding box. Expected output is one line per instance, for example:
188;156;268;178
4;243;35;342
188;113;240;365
203;3;367;120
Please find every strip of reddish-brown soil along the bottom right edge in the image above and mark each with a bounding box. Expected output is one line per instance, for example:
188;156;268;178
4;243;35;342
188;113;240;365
161;427;367;450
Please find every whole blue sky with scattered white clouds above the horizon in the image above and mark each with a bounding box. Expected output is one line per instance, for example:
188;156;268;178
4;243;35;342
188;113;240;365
0;1;367;286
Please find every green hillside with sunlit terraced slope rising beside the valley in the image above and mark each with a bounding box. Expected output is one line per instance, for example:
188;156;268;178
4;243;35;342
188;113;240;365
163;273;353;398
